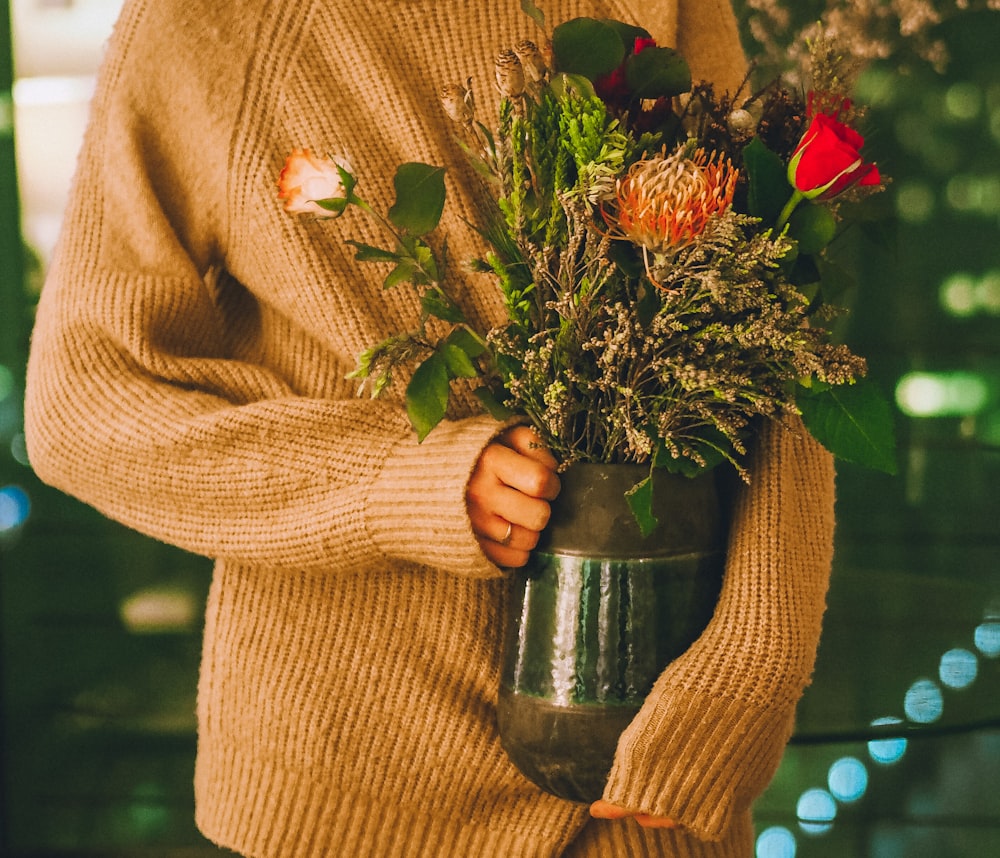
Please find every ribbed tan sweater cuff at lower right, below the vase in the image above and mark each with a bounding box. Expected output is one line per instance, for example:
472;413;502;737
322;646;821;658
603;690;795;840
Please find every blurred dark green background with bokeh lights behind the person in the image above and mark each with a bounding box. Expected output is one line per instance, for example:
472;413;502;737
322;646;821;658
0;0;1000;858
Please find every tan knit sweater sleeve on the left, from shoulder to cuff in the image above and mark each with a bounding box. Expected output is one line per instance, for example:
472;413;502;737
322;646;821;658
26;0;508;577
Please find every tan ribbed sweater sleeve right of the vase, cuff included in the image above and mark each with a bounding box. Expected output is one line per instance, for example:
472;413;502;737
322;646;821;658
605;420;834;840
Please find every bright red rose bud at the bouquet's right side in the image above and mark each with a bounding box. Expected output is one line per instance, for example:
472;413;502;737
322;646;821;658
788;113;882;200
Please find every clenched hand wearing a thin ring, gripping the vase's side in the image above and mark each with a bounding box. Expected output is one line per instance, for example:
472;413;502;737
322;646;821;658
465;426;559;566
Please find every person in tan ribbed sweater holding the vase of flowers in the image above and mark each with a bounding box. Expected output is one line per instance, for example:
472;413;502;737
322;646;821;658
26;0;833;858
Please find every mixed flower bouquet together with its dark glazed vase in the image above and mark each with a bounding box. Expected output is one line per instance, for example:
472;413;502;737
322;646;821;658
279;0;894;801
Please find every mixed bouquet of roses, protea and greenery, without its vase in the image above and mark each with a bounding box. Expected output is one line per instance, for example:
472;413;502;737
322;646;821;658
279;0;894;531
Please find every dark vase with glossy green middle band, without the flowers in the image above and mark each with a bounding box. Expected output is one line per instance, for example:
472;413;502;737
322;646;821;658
497;464;728;802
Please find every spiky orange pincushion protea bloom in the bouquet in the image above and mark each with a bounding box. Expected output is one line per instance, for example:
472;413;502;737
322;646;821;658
603;149;738;258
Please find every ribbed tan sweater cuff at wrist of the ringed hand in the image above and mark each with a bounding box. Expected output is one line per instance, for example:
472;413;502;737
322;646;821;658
366;416;507;578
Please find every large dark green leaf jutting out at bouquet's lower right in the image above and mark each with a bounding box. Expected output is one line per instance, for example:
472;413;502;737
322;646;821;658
796;379;897;474
